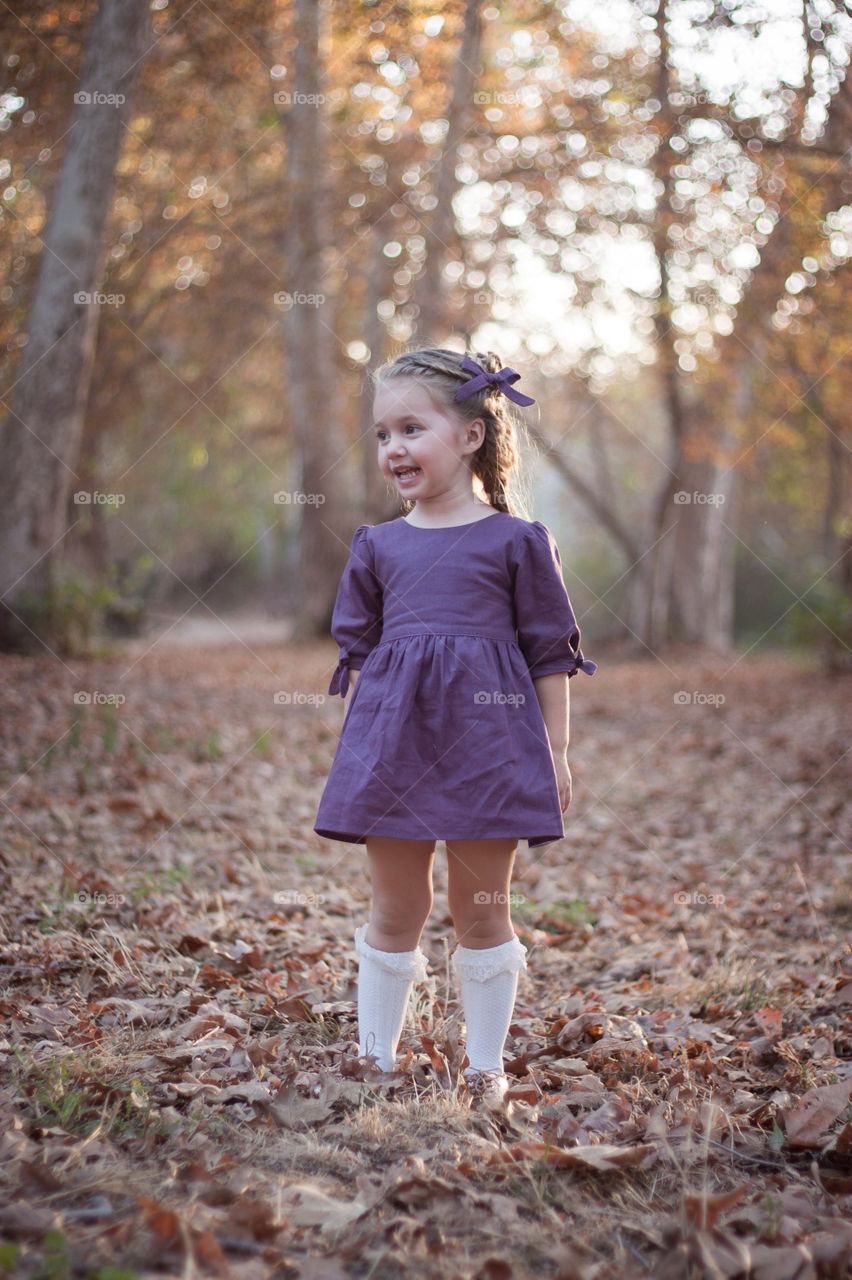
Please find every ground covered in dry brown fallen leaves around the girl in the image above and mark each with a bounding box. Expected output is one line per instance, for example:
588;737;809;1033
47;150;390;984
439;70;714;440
0;639;852;1280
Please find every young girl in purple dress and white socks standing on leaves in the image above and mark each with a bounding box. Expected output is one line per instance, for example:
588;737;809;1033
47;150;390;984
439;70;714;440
313;348;596;1106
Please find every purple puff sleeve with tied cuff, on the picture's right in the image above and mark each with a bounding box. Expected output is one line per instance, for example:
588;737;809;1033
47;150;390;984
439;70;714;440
510;520;597;680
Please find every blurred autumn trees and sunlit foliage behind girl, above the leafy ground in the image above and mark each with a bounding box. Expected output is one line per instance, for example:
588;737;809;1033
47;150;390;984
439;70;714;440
0;0;852;669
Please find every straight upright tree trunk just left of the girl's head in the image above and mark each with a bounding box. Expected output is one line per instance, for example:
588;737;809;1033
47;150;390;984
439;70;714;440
280;0;357;639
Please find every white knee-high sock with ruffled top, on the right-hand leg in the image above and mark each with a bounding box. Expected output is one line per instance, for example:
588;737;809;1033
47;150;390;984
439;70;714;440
453;934;527;1075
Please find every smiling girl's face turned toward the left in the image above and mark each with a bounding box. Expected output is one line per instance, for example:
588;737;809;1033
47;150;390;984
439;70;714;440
374;378;485;502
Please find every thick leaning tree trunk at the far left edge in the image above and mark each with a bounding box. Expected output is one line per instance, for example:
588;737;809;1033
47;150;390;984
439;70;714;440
0;0;150;648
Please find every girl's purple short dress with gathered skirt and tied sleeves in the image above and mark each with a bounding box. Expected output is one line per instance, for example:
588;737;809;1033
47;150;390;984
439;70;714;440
313;512;596;846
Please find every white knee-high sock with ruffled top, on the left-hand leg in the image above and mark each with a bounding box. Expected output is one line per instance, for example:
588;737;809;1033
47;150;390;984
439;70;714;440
356;924;427;1071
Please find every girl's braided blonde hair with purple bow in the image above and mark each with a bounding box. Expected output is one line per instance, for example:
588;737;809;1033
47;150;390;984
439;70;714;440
370;347;531;520
